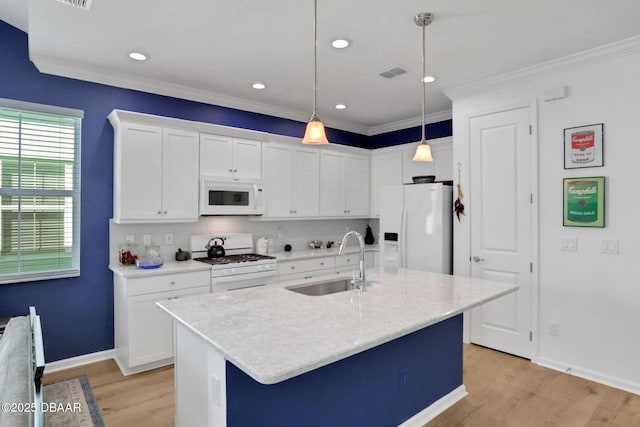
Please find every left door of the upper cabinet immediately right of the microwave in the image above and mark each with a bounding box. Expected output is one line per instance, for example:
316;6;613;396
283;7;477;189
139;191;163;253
262;144;294;217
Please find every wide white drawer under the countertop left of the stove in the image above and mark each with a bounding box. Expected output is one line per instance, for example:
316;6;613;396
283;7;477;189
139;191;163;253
127;270;211;295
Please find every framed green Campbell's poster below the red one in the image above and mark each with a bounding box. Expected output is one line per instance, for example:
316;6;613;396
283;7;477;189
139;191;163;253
562;176;605;228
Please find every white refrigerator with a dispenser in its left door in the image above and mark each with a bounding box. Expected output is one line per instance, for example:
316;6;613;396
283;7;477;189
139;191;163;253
378;183;453;274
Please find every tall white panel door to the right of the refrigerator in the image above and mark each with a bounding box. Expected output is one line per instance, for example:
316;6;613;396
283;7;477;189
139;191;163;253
468;107;532;358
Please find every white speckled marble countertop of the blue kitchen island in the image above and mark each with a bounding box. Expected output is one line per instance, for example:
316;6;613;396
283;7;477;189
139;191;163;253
157;267;518;384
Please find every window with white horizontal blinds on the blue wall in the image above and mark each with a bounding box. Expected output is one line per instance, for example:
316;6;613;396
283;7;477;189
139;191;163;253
0;99;82;283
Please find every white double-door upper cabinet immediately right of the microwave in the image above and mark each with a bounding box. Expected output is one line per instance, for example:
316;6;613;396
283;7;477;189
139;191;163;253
262;143;320;218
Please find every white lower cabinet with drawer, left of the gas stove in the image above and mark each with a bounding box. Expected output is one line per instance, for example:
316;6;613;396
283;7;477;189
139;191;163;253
114;270;211;375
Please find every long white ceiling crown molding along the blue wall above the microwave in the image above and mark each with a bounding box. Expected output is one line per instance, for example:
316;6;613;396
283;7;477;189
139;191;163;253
29;54;370;135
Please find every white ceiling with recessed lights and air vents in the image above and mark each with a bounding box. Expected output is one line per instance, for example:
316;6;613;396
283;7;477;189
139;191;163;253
0;0;640;134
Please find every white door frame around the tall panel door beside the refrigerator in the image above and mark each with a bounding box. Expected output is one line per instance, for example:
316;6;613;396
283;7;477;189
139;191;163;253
453;98;540;363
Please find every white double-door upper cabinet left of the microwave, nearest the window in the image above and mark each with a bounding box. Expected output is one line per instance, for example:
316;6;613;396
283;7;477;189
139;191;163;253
112;120;198;224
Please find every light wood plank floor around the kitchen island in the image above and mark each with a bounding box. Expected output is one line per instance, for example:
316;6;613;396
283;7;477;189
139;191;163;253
44;345;640;427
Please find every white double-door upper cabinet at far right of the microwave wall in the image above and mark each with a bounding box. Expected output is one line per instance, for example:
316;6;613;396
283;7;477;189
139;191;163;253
320;150;369;217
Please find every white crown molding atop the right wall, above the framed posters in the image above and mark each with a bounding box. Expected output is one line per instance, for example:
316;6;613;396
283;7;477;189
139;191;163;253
444;36;640;100
